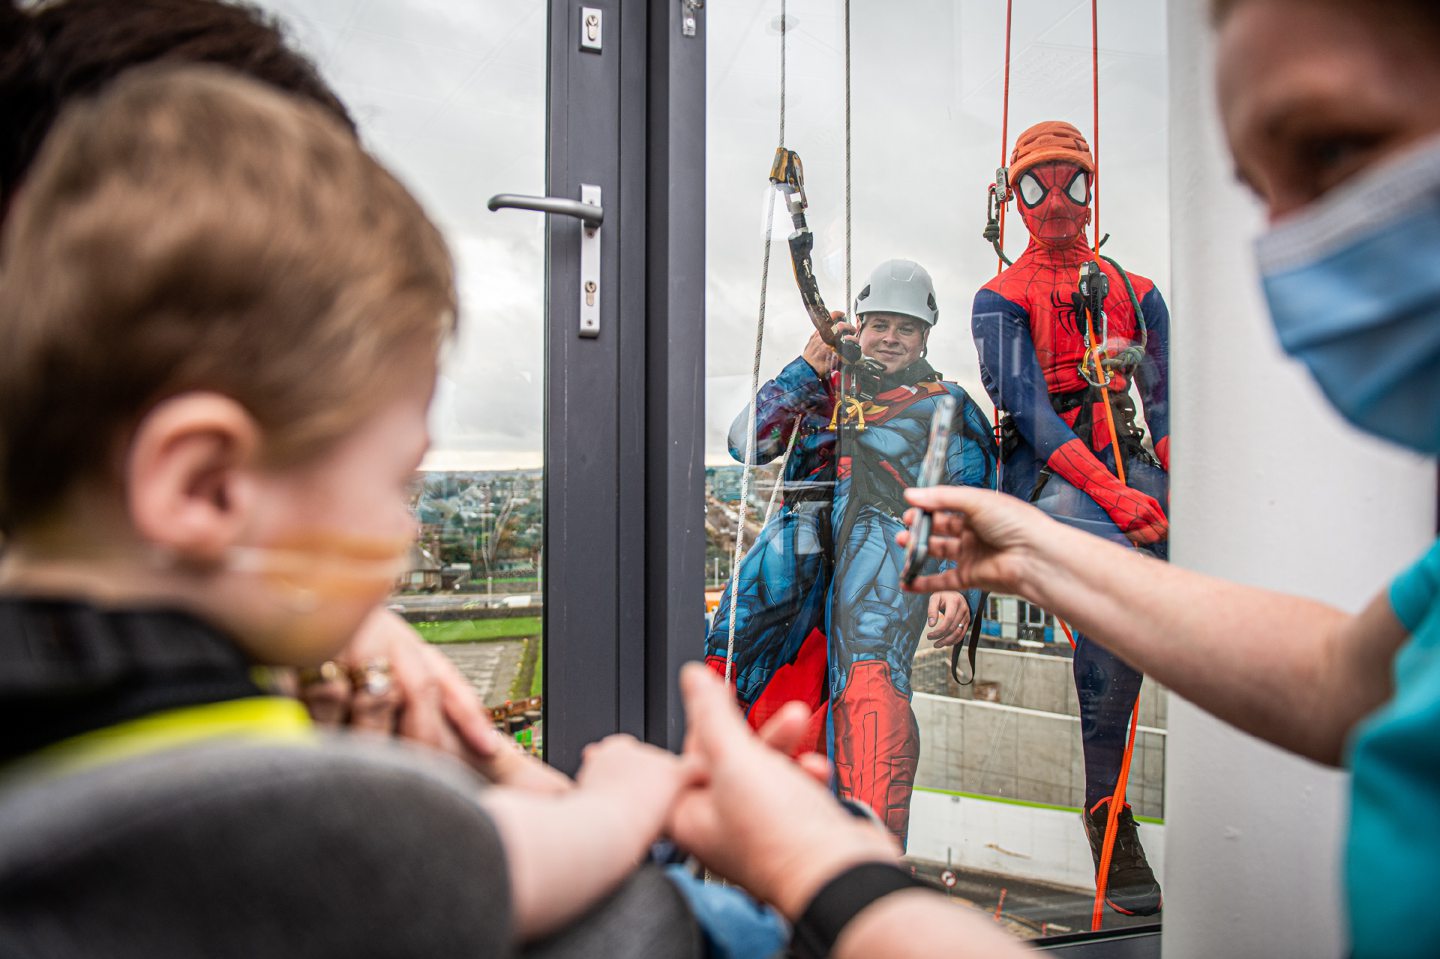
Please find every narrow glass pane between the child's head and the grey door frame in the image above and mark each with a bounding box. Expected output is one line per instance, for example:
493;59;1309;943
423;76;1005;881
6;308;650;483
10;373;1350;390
264;0;546;752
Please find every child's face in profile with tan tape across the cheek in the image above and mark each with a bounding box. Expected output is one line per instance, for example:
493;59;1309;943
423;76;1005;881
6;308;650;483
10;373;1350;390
233;364;435;665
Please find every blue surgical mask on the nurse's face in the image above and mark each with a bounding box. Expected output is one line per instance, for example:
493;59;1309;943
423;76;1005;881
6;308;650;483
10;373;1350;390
1256;140;1440;454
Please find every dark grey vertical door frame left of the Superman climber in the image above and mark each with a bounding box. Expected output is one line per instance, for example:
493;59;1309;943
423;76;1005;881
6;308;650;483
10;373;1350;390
544;7;1161;959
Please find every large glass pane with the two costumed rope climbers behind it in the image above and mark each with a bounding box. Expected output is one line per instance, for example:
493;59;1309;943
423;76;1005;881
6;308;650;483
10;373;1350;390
706;0;1169;937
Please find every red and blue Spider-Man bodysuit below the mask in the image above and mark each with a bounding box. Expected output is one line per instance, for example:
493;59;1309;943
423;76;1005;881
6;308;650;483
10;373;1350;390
972;230;1169;808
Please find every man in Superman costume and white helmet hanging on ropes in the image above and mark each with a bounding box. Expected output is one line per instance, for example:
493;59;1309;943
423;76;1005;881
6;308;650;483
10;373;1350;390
706;259;995;845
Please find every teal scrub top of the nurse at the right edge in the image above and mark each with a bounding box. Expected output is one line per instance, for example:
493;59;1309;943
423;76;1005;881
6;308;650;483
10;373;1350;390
1345;541;1440;959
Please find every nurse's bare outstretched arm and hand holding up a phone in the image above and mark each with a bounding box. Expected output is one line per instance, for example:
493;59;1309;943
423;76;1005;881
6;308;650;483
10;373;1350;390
901;488;1405;765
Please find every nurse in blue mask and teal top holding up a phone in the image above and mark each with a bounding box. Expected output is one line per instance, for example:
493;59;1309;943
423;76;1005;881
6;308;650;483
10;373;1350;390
901;0;1440;958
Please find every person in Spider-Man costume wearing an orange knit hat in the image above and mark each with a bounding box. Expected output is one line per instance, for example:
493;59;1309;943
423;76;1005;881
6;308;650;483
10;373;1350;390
972;121;1169;916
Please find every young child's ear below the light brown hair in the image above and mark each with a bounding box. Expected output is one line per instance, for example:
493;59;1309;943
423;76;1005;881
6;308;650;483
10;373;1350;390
125;393;261;563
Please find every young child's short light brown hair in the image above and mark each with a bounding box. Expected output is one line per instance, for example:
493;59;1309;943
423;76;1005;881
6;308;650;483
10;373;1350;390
0;66;455;531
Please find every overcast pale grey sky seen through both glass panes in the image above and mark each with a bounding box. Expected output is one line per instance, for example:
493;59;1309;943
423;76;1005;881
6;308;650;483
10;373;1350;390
253;0;1163;468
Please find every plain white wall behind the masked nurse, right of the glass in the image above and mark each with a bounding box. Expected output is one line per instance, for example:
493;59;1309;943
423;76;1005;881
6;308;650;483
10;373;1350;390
1163;0;1436;959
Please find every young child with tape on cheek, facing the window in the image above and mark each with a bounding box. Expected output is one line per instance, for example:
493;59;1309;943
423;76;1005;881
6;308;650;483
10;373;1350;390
0;68;693;956
